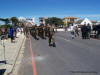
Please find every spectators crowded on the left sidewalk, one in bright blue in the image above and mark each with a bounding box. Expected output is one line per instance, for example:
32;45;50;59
0;26;23;43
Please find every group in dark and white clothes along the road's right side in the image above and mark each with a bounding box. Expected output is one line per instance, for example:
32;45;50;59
70;24;100;39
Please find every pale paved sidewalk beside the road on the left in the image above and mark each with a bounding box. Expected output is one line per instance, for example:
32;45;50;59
0;34;25;75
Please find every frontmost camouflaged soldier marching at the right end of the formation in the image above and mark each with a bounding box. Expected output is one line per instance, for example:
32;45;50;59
48;24;56;47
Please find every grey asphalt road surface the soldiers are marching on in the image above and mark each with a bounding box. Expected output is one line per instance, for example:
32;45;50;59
19;32;100;75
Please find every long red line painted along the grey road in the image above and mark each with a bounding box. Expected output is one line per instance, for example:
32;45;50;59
29;36;37;75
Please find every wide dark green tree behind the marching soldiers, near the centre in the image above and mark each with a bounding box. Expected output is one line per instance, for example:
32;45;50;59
46;17;64;27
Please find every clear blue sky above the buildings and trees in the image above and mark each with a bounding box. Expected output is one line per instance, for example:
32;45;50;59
0;0;100;20
